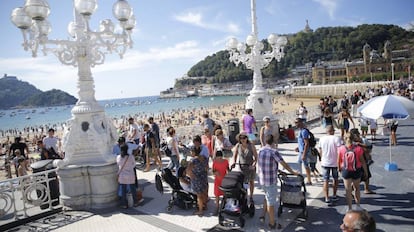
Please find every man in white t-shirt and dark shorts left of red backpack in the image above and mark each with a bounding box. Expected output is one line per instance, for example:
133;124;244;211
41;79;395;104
317;125;342;206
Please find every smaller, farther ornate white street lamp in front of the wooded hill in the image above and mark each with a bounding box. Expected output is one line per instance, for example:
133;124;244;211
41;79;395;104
227;0;287;119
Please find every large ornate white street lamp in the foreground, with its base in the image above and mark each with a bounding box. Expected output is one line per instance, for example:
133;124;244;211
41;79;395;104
11;0;135;208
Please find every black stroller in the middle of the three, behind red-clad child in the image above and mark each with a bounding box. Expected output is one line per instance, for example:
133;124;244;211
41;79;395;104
218;171;255;228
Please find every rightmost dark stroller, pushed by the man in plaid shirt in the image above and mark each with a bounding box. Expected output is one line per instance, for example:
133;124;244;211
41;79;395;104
277;172;308;219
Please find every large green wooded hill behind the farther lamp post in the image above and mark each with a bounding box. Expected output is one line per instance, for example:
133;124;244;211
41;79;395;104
174;24;414;88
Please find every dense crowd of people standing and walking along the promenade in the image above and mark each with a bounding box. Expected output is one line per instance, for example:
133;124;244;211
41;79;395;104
7;80;414;231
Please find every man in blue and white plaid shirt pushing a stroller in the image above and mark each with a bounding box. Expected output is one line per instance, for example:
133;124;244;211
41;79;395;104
257;134;298;229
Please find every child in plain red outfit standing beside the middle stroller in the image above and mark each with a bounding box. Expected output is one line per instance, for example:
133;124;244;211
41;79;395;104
213;151;229;216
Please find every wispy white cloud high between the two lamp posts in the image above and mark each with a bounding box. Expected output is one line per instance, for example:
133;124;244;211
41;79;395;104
174;11;241;34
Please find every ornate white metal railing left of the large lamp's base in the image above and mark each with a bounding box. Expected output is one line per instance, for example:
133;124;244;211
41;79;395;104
0;169;62;227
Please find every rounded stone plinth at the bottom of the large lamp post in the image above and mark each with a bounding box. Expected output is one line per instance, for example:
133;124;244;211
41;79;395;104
57;163;118;210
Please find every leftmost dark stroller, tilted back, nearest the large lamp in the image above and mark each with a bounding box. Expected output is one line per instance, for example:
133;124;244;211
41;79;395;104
161;168;197;213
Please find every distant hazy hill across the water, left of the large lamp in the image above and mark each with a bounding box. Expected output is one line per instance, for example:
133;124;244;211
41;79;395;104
0;75;77;109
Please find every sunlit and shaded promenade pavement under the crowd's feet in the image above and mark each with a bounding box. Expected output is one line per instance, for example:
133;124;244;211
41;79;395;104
8;115;414;232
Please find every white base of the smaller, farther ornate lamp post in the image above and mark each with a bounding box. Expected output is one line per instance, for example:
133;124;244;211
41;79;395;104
246;89;273;121
